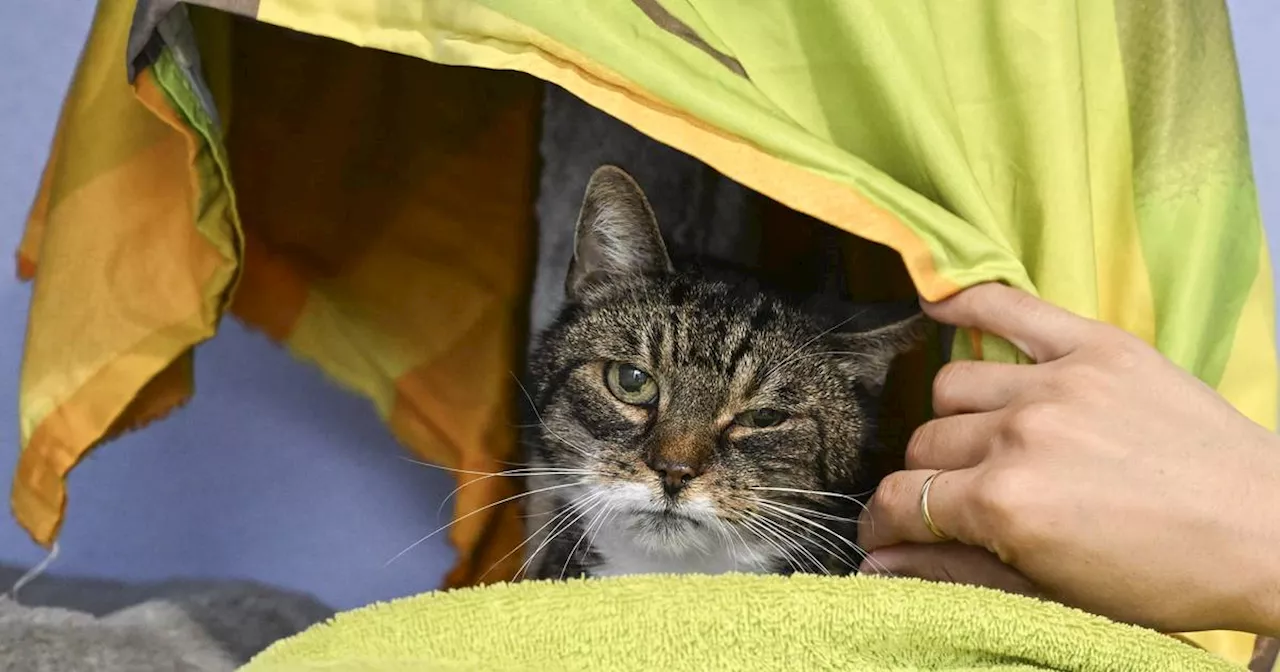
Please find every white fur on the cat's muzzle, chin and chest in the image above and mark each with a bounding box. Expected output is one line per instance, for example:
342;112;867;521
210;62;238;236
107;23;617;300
591;483;776;576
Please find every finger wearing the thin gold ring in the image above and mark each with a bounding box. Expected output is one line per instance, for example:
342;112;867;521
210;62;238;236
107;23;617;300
858;468;978;552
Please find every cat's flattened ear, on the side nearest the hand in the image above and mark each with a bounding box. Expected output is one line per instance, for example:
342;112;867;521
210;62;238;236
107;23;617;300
832;301;932;396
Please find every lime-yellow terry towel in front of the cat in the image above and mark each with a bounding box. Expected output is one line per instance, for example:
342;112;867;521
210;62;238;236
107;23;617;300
242;575;1238;672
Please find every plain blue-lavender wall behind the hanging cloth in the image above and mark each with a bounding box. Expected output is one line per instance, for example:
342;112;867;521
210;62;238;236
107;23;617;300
0;0;1280;608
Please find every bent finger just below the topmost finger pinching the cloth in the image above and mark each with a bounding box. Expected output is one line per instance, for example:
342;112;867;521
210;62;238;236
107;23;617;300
933;361;1044;416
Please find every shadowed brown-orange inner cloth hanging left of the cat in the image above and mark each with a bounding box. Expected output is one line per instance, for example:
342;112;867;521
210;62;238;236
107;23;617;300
221;19;541;585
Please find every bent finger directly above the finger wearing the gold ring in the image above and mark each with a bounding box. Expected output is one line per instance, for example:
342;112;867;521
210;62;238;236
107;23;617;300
905;412;1002;468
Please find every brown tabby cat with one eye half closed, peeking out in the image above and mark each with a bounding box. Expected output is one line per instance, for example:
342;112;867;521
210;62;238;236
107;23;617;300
525;165;927;579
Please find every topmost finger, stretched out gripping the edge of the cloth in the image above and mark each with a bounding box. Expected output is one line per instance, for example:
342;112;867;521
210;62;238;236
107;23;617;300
922;283;1096;362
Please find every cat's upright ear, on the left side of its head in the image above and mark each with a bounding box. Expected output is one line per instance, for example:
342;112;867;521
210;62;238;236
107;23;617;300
564;165;672;297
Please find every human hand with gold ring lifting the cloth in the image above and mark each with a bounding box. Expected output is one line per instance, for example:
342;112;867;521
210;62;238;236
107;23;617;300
859;284;1280;634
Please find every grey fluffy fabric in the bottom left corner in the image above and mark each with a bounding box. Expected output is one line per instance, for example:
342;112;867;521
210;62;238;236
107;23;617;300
0;566;333;672
